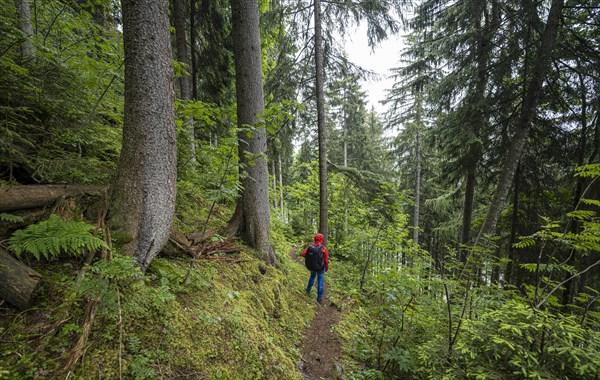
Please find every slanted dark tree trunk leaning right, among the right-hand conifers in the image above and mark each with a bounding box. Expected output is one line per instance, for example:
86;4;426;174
476;0;564;243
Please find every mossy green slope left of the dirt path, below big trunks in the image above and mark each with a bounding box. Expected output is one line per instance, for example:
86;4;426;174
0;239;314;380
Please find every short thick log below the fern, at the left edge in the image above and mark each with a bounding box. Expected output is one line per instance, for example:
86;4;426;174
0;248;42;310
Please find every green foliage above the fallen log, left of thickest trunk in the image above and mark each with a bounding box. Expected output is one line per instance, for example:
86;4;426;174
0;0;123;183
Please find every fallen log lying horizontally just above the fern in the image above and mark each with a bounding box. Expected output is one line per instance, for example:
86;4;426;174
0;185;108;211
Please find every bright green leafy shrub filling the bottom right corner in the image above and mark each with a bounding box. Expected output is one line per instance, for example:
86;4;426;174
448;299;600;379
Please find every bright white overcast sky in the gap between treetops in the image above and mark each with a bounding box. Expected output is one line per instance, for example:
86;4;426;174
345;25;403;114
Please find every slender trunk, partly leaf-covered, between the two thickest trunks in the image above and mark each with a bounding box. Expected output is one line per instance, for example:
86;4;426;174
173;0;196;162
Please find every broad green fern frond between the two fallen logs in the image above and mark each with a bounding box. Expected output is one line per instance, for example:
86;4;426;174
8;215;108;260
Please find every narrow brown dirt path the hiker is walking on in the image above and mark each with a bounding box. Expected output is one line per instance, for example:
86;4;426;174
290;250;342;380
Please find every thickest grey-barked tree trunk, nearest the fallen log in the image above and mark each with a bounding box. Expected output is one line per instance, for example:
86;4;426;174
110;0;177;270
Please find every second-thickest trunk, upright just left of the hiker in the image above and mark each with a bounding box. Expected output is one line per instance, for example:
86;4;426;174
231;0;275;264
